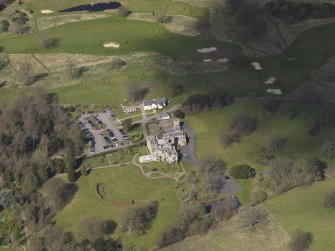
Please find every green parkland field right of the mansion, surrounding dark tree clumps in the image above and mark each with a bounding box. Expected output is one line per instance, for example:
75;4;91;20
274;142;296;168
185;101;332;170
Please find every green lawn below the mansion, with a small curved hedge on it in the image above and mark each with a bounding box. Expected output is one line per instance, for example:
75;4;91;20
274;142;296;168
55;167;179;248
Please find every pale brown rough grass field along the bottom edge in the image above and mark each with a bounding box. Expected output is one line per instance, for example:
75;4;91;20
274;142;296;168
162;205;289;251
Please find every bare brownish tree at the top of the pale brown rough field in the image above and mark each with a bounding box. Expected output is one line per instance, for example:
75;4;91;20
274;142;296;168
241;207;269;228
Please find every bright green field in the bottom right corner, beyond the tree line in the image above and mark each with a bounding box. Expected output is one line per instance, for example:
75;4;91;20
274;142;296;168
266;180;335;251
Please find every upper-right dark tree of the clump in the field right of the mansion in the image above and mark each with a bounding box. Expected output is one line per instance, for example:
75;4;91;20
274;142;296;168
229;113;257;136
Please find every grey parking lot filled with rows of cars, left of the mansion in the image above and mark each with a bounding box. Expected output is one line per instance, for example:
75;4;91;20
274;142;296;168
77;110;131;155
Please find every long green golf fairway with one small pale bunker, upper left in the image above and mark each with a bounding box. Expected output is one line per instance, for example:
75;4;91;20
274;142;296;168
0;17;238;58
